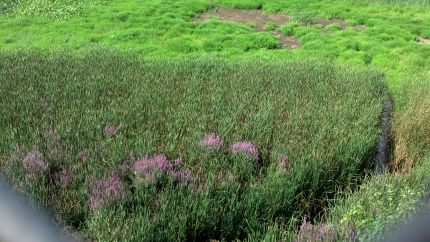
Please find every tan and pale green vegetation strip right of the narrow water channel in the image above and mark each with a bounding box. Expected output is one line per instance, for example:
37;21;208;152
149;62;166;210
322;78;430;241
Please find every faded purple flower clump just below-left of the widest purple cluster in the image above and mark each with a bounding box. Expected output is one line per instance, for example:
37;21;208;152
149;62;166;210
88;167;130;211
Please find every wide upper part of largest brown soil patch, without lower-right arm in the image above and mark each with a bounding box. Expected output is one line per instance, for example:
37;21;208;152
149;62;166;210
196;7;290;32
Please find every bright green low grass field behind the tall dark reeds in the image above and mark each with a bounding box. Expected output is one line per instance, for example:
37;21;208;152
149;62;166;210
0;0;430;89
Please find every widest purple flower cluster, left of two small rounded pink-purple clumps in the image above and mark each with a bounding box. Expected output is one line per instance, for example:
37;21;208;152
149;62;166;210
134;154;193;184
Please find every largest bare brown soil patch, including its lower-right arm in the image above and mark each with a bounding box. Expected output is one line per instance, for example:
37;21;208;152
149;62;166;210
194;7;300;49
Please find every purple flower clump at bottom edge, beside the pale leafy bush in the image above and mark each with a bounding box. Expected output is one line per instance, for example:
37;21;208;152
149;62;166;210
295;217;337;242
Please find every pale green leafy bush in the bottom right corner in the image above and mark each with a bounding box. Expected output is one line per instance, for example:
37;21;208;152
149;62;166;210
328;175;424;241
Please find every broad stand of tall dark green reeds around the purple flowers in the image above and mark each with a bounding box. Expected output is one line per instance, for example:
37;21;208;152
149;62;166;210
0;51;387;241
